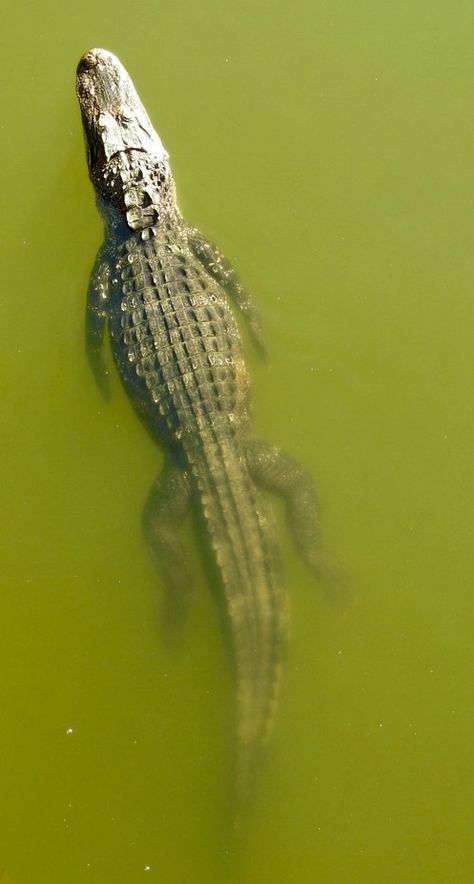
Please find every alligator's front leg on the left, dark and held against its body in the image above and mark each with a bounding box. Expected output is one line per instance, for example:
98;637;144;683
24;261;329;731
85;246;111;399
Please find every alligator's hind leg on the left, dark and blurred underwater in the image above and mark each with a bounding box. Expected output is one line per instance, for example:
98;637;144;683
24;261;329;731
143;463;192;635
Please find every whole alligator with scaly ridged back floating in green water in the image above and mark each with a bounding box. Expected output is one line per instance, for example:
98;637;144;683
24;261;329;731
77;49;340;792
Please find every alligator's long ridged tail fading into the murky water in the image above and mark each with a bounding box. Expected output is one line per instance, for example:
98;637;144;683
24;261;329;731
190;439;287;801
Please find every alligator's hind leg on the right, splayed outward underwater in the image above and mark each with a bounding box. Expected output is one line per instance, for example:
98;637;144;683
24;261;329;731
246;440;348;604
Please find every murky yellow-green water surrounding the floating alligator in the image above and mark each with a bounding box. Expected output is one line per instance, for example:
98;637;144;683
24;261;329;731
0;0;474;884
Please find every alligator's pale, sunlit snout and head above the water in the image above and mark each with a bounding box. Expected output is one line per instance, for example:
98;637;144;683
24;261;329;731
76;49;168;169
